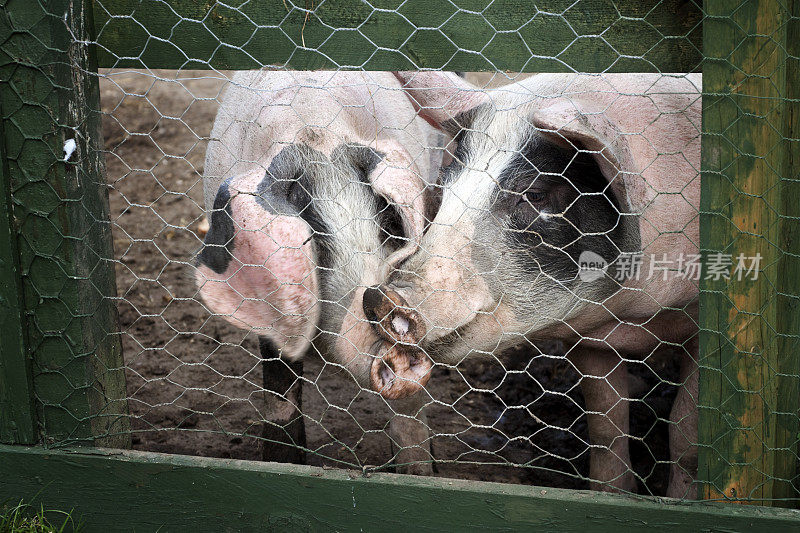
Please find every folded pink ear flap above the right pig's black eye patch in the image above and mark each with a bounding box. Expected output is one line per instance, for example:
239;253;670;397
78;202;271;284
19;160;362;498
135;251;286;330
533;101;637;207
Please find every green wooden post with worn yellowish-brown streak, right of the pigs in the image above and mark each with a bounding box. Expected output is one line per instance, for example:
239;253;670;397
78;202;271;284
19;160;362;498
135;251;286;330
699;0;800;505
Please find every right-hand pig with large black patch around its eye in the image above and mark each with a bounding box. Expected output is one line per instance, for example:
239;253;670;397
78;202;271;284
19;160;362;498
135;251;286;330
363;72;701;497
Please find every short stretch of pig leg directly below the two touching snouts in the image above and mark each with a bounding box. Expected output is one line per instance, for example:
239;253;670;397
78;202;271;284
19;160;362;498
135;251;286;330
389;394;433;476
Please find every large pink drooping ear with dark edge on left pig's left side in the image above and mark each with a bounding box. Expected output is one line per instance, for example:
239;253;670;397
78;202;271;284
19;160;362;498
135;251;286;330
195;169;319;359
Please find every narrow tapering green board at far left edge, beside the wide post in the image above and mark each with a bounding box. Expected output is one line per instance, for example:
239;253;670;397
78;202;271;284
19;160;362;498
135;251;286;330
0;88;36;444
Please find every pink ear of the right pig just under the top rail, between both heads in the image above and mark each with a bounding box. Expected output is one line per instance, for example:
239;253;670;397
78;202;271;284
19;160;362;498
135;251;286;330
395;71;490;129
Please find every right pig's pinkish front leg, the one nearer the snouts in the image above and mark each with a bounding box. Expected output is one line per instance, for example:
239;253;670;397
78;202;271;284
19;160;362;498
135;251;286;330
569;346;636;492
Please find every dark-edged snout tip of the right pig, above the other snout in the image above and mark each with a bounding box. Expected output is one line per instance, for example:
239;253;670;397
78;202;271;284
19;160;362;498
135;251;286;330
363;286;425;347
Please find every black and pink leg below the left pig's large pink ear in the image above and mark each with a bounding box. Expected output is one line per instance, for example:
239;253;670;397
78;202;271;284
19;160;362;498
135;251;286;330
259;337;306;464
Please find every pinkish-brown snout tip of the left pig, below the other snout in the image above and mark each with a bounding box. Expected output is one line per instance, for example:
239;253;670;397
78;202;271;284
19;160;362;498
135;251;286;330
370;346;433;400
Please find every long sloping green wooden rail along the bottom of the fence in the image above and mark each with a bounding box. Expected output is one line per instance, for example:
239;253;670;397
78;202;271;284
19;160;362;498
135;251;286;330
0;446;800;533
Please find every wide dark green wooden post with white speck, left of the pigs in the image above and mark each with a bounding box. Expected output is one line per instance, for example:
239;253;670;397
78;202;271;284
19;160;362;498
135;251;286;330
0;0;130;446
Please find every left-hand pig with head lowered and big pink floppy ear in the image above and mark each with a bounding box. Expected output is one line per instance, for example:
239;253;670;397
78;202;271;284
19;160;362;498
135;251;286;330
195;71;442;474
